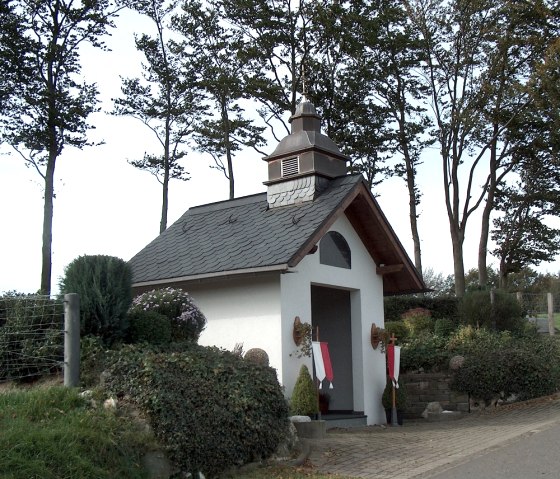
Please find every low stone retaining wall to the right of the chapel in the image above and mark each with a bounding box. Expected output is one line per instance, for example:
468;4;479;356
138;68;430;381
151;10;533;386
400;373;469;419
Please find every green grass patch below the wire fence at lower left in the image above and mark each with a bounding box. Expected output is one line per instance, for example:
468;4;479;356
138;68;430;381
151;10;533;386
0;387;148;479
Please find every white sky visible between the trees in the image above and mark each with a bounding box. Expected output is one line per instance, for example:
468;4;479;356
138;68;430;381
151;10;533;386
0;13;560;292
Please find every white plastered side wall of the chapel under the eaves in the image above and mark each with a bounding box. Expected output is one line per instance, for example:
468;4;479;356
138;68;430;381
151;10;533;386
185;273;282;380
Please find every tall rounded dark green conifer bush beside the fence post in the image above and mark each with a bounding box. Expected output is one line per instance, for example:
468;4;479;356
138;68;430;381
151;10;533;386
60;255;132;344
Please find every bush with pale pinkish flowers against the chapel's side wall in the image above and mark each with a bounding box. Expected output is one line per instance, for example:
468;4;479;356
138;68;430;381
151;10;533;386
129;288;206;342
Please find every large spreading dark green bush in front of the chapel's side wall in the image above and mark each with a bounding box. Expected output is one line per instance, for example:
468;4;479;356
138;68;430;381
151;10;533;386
105;342;288;477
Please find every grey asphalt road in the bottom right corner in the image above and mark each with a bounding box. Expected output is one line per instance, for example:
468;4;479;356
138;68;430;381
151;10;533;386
423;424;560;479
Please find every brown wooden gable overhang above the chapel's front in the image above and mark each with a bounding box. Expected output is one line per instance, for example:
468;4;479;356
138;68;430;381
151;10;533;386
288;181;428;296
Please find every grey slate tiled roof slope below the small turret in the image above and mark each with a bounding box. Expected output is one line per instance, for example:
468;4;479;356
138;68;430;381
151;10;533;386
130;175;364;284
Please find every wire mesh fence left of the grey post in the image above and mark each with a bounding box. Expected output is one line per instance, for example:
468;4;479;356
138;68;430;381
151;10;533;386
0;294;64;382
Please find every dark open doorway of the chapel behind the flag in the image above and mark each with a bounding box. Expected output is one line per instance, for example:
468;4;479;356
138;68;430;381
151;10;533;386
311;286;354;411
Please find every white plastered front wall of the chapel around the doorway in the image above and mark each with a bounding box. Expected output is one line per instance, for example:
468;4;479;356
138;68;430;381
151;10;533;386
280;216;385;424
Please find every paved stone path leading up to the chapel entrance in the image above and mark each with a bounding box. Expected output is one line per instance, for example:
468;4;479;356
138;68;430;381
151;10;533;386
310;397;560;479
